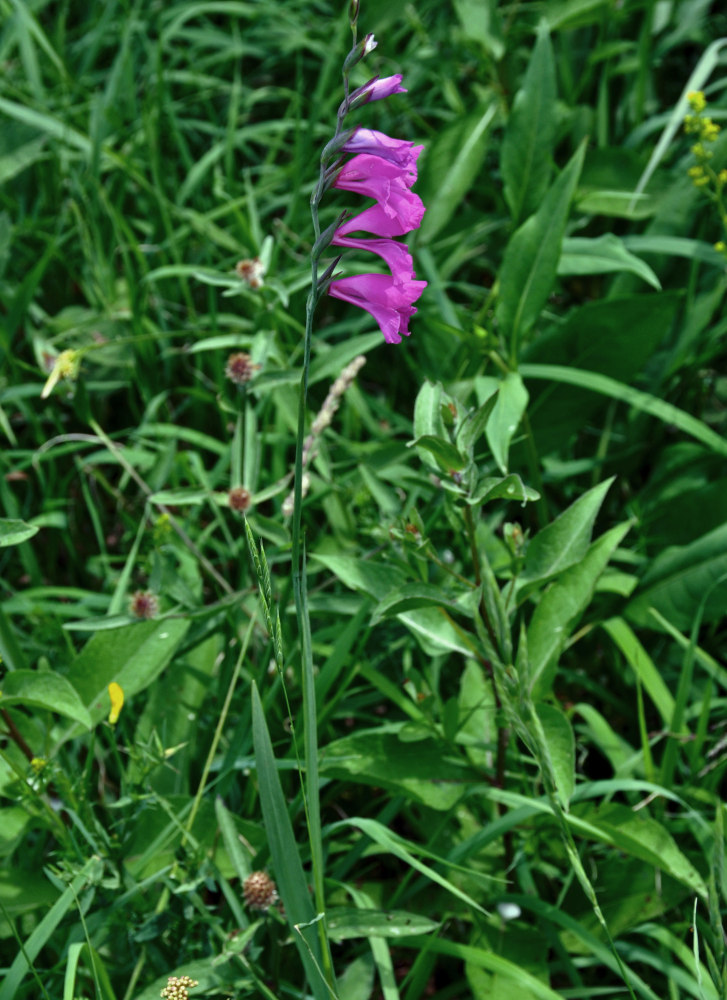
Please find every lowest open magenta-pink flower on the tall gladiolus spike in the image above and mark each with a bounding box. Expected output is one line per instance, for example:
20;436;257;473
328;274;427;344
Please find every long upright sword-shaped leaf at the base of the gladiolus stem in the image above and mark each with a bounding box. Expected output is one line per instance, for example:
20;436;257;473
252;681;329;1000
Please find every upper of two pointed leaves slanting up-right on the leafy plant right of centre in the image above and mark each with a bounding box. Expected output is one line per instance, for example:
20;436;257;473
517;477;613;591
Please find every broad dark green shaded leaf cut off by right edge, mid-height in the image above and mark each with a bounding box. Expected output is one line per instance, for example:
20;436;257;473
625;525;727;631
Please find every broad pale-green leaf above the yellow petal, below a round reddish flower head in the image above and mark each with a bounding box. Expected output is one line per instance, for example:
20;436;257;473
68;618;190;723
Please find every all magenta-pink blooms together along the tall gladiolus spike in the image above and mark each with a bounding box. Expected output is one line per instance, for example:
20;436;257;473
328;74;427;344
